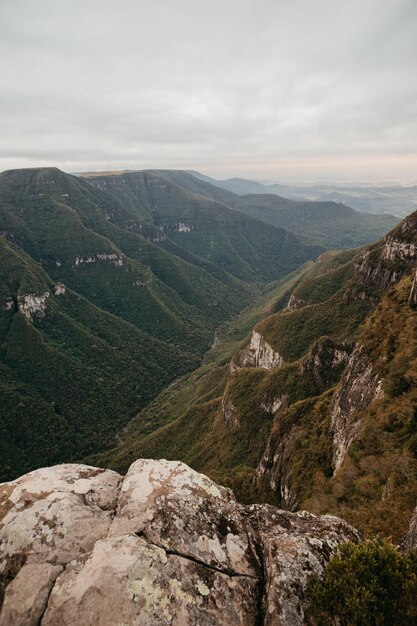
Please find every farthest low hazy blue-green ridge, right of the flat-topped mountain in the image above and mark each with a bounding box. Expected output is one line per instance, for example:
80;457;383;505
231;193;398;248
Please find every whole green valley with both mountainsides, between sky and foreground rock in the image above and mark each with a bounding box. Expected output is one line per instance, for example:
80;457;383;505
0;163;417;534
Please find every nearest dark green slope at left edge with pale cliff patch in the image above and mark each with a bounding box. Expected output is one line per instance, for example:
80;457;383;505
0;237;191;481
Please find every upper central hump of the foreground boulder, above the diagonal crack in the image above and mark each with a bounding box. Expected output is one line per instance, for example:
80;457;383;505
109;459;255;576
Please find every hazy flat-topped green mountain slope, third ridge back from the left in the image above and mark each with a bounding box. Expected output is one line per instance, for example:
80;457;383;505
83;171;322;282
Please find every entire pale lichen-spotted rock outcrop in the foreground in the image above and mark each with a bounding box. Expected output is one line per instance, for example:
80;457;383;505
0;460;358;626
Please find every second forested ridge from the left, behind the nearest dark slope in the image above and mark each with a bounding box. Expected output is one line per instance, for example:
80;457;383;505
0;168;251;354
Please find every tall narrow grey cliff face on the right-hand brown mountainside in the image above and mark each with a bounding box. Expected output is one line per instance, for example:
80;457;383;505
330;345;383;472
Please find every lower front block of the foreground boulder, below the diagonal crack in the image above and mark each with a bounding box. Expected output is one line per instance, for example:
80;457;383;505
42;535;257;626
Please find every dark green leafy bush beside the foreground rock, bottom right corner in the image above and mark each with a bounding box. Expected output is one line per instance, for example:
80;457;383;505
309;539;417;626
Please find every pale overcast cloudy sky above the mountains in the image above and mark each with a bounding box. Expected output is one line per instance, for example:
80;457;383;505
0;0;417;183
